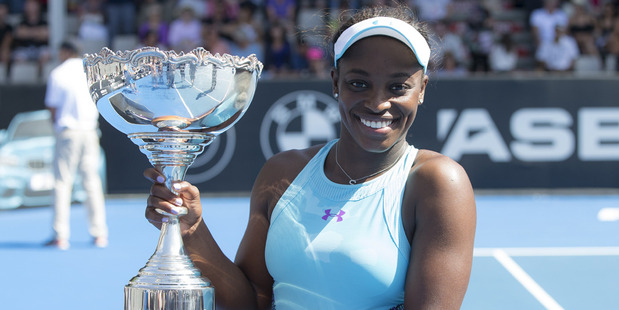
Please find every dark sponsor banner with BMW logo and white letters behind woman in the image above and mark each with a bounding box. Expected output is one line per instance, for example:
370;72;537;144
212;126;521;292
0;78;619;193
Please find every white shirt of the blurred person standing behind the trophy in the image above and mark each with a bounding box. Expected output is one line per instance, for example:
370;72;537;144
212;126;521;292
45;58;99;131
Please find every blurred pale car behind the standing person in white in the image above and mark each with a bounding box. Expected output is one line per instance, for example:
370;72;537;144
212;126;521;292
0;110;106;209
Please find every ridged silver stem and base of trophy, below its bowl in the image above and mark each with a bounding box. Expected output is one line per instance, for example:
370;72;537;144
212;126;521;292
125;131;215;310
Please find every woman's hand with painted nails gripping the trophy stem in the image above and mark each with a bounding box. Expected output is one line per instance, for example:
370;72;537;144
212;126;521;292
144;168;202;236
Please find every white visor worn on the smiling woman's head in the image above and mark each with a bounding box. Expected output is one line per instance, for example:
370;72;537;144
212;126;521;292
333;17;430;73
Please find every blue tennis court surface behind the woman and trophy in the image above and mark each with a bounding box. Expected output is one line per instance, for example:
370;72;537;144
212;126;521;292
0;194;619;310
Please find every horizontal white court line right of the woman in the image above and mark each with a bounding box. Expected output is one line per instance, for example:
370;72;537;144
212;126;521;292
473;246;619;257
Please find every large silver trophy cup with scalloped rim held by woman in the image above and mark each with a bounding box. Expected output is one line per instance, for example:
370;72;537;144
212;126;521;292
84;47;262;310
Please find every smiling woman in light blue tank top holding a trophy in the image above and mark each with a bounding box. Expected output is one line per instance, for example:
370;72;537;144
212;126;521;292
145;3;475;309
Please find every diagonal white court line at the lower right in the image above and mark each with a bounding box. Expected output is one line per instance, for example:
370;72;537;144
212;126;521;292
493;249;563;310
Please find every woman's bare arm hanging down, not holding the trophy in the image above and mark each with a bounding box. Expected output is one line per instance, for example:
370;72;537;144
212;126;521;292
403;154;476;310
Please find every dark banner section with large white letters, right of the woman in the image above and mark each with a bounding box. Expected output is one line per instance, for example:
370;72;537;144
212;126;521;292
408;79;619;189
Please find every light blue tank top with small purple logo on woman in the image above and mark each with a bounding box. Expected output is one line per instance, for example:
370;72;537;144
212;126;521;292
265;140;417;310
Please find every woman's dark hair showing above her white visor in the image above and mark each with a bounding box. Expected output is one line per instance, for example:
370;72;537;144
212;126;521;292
329;2;432;68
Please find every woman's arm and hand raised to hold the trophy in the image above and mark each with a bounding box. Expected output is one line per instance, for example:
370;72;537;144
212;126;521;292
144;149;317;310
